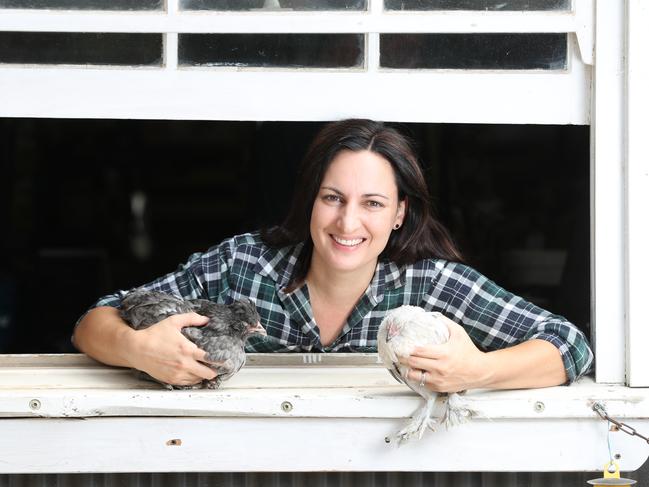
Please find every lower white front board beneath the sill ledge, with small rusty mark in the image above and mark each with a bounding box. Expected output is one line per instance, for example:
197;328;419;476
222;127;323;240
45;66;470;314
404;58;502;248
0;418;647;473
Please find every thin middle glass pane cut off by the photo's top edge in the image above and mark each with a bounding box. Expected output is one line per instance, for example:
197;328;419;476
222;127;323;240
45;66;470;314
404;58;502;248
180;0;367;10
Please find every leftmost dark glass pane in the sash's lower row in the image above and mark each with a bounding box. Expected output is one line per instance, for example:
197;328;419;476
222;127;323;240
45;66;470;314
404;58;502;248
0;32;162;66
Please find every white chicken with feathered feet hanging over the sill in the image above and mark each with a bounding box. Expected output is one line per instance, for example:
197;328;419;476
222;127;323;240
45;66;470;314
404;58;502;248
377;306;473;444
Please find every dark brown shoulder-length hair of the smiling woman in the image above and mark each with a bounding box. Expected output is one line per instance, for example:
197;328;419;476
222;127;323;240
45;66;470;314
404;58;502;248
262;119;463;284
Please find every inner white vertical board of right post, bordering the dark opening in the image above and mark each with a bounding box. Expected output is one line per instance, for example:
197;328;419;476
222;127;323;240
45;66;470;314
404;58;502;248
591;0;626;384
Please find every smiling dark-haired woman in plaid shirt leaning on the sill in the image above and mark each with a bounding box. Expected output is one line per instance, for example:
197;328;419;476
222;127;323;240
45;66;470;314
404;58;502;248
74;120;593;392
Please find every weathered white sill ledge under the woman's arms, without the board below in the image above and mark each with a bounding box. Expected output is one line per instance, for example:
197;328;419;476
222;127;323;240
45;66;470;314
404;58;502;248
0;354;649;419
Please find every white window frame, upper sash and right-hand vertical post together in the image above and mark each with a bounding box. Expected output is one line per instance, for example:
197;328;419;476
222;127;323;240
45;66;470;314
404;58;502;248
0;0;649;386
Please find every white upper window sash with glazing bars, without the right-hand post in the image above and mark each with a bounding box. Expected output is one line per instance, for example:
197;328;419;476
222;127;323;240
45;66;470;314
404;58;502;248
0;0;592;124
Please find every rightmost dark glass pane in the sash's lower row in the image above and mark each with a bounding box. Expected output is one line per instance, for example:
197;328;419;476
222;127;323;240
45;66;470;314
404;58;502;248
381;34;567;69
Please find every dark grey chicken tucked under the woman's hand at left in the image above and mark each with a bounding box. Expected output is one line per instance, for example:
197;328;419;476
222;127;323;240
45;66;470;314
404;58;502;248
119;289;266;389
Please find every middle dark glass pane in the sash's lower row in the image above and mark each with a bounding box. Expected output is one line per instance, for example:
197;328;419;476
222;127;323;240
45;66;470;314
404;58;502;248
178;34;364;68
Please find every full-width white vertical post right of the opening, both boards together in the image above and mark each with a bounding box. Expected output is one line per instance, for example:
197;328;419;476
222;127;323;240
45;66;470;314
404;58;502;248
591;0;649;387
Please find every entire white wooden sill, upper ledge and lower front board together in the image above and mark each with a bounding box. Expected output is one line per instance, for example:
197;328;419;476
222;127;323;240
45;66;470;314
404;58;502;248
0;354;649;473
